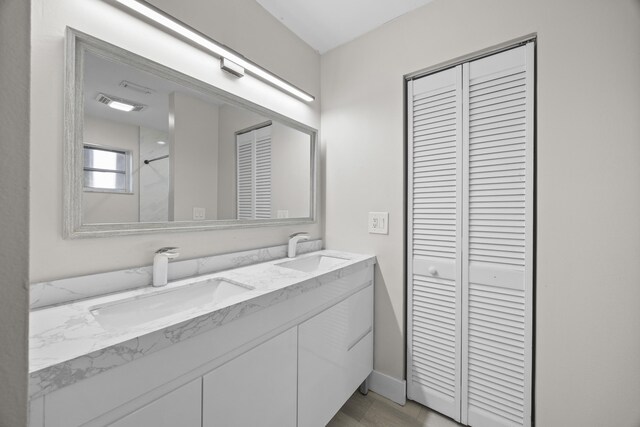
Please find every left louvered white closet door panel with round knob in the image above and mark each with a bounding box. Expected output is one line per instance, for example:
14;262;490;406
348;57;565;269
407;67;462;420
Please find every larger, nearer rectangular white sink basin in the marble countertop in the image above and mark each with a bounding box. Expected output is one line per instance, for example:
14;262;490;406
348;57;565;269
91;278;253;329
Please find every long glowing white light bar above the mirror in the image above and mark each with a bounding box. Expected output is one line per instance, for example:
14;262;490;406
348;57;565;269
113;0;315;102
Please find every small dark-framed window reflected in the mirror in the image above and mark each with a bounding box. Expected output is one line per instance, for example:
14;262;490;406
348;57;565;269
84;145;131;193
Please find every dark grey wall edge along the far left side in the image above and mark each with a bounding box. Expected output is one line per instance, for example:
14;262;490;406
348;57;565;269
0;0;30;427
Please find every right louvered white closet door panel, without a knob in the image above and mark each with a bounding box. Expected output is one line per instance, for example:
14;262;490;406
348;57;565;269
462;43;533;427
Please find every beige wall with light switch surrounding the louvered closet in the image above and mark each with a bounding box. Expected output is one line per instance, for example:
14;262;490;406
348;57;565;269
322;0;640;427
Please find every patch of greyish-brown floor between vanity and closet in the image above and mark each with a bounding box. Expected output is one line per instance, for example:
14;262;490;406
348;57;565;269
327;391;461;427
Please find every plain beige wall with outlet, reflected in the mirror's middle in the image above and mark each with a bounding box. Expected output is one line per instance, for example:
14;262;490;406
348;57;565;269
169;92;218;221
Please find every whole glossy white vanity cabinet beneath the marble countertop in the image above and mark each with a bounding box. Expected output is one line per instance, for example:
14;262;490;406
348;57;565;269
30;264;373;427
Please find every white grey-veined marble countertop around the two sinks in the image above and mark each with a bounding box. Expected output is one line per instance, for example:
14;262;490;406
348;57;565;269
29;250;376;398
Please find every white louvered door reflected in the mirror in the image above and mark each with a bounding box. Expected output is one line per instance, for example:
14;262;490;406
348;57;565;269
236;123;271;219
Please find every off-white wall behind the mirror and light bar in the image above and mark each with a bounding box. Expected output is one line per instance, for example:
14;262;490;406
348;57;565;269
30;0;321;282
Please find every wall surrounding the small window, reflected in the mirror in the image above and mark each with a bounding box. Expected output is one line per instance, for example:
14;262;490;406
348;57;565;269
82;116;139;224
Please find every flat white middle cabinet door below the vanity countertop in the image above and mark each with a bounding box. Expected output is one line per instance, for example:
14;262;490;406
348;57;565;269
202;327;297;427
